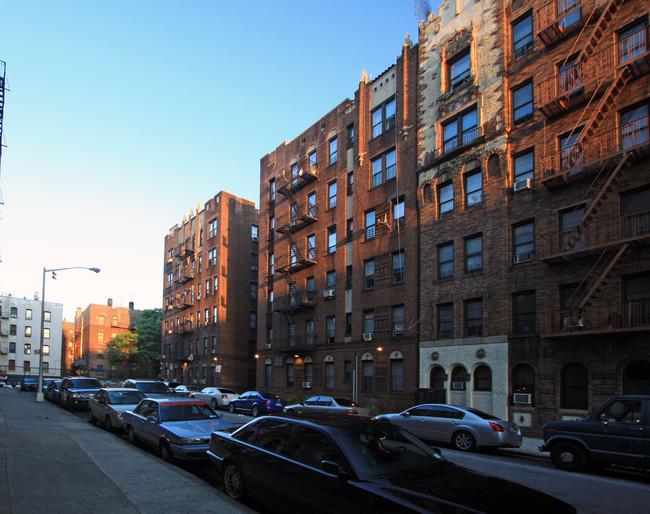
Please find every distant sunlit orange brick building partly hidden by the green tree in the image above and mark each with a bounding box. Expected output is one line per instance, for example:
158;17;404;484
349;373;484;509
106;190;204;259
69;298;142;380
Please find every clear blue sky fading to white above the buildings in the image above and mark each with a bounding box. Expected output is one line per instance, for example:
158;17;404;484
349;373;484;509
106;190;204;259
0;0;439;321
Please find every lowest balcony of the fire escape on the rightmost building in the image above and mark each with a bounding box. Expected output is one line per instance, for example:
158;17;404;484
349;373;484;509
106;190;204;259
540;300;650;337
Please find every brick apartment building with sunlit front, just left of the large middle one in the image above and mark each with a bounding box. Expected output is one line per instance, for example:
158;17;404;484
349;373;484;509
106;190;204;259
161;191;259;392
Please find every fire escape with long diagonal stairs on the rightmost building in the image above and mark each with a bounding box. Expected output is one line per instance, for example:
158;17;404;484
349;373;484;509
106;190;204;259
537;0;650;336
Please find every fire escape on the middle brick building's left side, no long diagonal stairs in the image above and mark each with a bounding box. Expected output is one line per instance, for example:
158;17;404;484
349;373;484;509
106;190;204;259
275;164;318;352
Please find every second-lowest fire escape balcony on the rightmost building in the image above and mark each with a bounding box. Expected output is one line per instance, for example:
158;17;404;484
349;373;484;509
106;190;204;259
540;209;650;263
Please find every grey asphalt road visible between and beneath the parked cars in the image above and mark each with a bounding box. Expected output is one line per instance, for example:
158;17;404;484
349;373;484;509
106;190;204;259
68;402;650;514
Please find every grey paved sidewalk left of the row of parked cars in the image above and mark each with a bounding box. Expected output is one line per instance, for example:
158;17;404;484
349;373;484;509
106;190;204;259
0;388;255;514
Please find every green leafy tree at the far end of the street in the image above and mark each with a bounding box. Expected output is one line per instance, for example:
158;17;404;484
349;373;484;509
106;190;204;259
108;309;162;377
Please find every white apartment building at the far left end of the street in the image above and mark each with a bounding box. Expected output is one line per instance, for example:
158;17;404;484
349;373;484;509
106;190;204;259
0;295;63;377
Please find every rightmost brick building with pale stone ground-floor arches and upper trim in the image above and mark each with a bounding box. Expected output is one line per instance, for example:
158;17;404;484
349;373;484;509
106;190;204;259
418;0;650;433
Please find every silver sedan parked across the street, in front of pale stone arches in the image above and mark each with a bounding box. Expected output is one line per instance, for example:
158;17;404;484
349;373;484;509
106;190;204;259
376;403;523;451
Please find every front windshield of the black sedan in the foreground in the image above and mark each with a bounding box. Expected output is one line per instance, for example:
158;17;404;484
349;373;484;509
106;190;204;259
335;427;444;476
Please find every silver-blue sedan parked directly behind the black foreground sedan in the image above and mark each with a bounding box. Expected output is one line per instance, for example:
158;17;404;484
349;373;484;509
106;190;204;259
122;398;236;460
